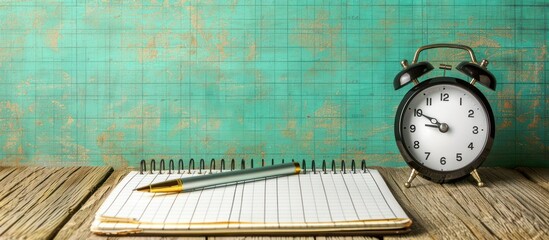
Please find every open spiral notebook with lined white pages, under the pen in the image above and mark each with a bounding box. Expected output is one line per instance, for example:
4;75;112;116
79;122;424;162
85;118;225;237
91;161;412;236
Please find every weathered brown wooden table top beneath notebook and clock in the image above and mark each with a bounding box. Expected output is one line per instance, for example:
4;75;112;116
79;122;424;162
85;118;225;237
0;167;549;239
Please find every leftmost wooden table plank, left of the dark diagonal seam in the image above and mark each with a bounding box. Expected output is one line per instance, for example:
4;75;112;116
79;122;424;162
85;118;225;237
0;167;112;239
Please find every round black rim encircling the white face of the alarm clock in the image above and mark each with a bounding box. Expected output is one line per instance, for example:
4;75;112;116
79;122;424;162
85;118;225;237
395;77;496;183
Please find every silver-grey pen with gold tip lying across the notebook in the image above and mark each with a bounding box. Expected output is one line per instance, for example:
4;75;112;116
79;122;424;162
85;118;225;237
134;162;301;193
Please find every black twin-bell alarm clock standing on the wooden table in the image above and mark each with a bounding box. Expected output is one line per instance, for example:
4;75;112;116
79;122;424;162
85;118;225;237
394;44;496;187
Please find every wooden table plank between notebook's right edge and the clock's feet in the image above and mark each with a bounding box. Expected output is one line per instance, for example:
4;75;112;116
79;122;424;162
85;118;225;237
379;168;495;239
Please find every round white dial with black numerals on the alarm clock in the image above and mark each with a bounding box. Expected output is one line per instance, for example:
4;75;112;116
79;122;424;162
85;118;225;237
400;84;490;171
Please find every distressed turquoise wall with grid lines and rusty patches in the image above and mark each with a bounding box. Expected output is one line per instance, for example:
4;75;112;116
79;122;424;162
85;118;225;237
0;0;549;167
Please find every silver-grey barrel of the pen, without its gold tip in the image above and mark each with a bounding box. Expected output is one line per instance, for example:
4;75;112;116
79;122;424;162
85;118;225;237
181;162;301;191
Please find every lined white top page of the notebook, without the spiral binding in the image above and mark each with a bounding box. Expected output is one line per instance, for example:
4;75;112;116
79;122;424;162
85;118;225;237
92;170;408;230
